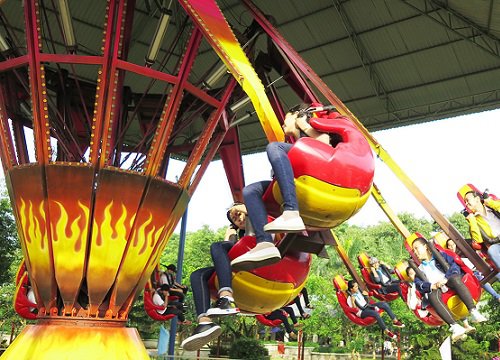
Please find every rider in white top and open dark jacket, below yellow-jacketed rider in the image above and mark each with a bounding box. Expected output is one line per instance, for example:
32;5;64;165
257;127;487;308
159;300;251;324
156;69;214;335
412;237;486;323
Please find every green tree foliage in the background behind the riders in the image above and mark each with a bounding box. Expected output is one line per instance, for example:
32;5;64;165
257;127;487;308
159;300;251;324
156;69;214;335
0;186;500;360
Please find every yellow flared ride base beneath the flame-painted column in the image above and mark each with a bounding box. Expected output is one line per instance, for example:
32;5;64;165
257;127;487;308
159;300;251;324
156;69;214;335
1;320;150;360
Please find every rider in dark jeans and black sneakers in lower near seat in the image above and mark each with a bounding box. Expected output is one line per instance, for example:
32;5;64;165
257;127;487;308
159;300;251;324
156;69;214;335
181;203;247;351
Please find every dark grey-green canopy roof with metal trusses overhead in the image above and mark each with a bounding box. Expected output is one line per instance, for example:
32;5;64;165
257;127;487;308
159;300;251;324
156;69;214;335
0;0;500;153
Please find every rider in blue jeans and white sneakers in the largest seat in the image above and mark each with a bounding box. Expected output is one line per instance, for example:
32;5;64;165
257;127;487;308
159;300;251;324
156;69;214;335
231;104;330;271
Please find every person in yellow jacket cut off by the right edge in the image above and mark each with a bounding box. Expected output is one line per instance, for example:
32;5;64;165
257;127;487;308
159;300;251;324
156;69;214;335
464;191;500;270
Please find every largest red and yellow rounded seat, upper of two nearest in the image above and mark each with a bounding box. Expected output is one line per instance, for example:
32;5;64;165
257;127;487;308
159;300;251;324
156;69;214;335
263;105;375;229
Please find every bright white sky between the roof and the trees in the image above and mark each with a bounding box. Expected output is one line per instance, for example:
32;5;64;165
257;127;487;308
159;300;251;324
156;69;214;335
169;110;500;232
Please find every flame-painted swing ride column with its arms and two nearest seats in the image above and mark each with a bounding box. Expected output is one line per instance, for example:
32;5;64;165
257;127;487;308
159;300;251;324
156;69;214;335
0;0;496;360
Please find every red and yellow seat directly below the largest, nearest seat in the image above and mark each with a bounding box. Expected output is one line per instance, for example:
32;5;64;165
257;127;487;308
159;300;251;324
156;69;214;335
209;236;312;314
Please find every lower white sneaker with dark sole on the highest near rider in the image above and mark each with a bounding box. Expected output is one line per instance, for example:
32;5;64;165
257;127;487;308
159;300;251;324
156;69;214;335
231;242;281;271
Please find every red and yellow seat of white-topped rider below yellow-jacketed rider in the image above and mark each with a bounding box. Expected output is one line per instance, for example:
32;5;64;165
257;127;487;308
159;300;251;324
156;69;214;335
405;232;481;319
